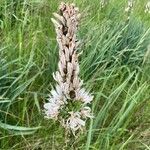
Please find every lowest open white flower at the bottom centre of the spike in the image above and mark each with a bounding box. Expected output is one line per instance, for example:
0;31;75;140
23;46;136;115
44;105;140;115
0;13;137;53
66;112;85;132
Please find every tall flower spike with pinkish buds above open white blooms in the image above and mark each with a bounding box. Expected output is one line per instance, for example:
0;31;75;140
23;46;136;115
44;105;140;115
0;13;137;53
44;3;93;133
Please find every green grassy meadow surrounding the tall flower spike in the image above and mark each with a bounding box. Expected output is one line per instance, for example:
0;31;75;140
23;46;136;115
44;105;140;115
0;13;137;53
0;0;150;150
